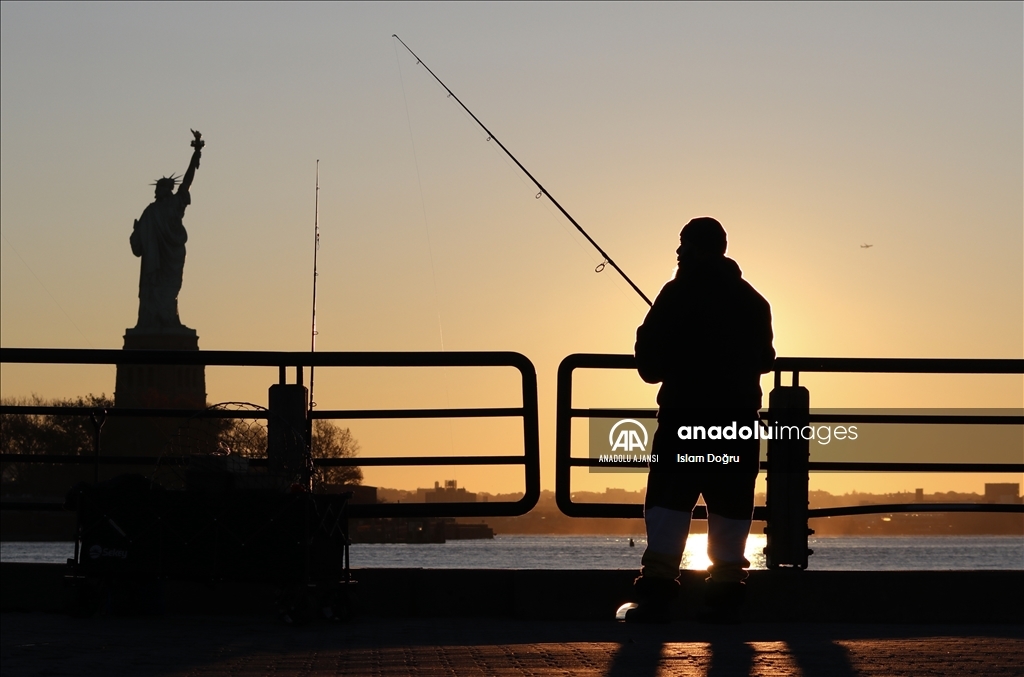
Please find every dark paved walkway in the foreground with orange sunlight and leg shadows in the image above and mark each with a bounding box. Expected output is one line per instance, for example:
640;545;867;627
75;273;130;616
0;613;1024;677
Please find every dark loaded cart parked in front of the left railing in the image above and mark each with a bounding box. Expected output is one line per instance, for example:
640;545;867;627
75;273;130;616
65;475;354;625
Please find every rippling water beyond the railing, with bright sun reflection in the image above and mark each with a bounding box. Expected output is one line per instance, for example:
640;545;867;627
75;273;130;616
0;534;1024;572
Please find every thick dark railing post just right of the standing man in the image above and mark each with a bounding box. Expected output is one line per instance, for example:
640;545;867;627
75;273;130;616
765;381;811;569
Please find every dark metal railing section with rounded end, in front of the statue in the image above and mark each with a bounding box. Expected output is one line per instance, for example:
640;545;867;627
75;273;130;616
0;348;541;517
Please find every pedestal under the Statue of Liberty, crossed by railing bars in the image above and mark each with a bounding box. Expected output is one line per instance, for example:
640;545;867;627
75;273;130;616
100;327;206;464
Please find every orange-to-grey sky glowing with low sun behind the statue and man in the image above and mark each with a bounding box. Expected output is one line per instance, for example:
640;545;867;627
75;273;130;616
0;3;1024;493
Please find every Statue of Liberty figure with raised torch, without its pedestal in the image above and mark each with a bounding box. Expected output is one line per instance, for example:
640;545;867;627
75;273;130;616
130;131;203;332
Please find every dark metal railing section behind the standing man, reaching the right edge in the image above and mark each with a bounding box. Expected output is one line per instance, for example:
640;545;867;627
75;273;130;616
555;353;1024;565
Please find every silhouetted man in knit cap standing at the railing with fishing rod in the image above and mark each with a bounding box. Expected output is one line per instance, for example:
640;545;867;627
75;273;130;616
626;217;775;623
